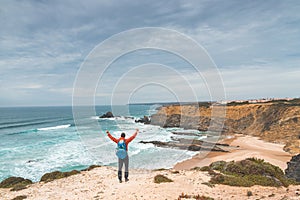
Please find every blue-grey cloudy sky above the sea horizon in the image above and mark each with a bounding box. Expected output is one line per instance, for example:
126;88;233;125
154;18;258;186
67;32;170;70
0;0;300;106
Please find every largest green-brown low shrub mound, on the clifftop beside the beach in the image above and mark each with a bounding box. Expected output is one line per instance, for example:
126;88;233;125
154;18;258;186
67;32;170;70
204;158;299;187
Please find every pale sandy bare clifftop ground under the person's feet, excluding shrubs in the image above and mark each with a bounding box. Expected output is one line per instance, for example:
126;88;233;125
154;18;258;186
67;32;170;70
0;166;299;200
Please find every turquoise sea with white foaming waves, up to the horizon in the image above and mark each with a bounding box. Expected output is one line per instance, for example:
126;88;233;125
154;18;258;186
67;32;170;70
0;105;201;181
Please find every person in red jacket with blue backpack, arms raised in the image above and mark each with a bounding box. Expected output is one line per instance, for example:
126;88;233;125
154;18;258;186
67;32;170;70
106;129;139;183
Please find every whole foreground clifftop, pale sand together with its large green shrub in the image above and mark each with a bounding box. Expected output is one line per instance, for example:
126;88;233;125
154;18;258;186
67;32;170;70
0;158;300;200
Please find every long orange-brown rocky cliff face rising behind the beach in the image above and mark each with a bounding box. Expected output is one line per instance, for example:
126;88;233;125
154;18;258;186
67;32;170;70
151;99;300;154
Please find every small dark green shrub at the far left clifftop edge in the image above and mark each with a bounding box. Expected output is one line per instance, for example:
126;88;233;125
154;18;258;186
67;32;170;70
0;177;32;191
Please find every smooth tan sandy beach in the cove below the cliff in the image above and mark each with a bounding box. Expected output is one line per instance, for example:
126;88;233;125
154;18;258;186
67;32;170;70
173;134;292;171
